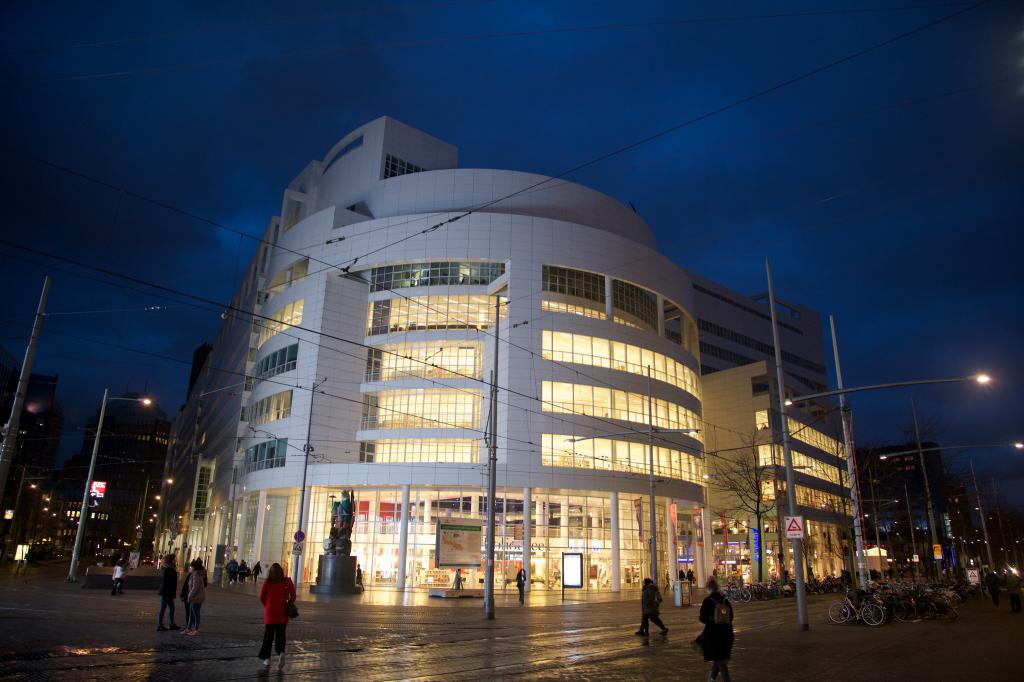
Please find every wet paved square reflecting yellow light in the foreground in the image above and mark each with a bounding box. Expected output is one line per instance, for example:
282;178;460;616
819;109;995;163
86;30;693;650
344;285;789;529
0;566;1024;682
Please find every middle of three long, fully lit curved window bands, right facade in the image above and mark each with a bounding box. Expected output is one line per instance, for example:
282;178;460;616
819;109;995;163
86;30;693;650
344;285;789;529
541;381;699;438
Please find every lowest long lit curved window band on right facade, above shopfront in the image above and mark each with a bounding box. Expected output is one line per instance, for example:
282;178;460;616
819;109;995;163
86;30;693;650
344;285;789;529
541;433;703;483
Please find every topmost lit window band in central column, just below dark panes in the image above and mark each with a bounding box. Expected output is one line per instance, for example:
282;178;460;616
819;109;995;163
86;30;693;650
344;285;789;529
368;294;508;336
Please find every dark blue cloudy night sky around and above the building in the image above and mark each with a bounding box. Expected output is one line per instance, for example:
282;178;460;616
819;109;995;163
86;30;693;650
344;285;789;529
0;0;1024;505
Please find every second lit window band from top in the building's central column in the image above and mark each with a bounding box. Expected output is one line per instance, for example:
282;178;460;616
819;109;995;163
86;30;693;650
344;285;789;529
366;341;483;381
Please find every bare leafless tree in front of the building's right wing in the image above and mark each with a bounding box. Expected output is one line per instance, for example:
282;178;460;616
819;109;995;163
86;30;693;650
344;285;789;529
709;432;776;582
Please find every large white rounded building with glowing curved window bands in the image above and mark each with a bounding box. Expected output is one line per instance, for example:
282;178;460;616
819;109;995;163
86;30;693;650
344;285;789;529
160;118;843;591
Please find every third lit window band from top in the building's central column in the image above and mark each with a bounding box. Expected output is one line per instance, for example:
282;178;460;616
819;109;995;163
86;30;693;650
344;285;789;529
362;389;480;429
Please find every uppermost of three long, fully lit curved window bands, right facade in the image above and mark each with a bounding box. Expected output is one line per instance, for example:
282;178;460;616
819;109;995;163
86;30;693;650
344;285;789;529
541;330;700;396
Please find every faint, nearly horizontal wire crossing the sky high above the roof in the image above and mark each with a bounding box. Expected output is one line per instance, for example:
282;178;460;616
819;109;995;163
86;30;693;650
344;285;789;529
42;2;983;83
